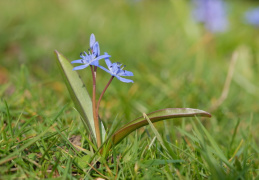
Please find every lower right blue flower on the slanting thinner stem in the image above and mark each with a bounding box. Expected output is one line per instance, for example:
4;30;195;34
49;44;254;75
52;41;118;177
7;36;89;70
99;53;133;83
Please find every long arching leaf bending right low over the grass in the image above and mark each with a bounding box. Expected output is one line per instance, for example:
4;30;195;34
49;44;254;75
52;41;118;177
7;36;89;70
108;108;211;147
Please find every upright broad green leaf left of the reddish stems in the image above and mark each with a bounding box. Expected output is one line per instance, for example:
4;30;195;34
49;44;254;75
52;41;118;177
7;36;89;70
55;51;105;140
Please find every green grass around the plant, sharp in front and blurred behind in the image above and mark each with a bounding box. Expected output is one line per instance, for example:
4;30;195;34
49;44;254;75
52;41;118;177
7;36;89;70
0;0;259;179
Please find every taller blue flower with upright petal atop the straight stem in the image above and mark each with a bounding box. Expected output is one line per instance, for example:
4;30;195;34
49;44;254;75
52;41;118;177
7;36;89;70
71;34;111;70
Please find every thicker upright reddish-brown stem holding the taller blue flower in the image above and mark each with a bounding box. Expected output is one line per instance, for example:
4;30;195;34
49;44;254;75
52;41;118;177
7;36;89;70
90;66;102;148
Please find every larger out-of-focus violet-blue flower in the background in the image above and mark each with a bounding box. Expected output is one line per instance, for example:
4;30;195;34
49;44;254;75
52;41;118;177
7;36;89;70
192;0;228;33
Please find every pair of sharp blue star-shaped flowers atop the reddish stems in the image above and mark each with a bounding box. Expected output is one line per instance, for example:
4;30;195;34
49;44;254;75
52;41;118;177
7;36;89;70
71;34;133;83
